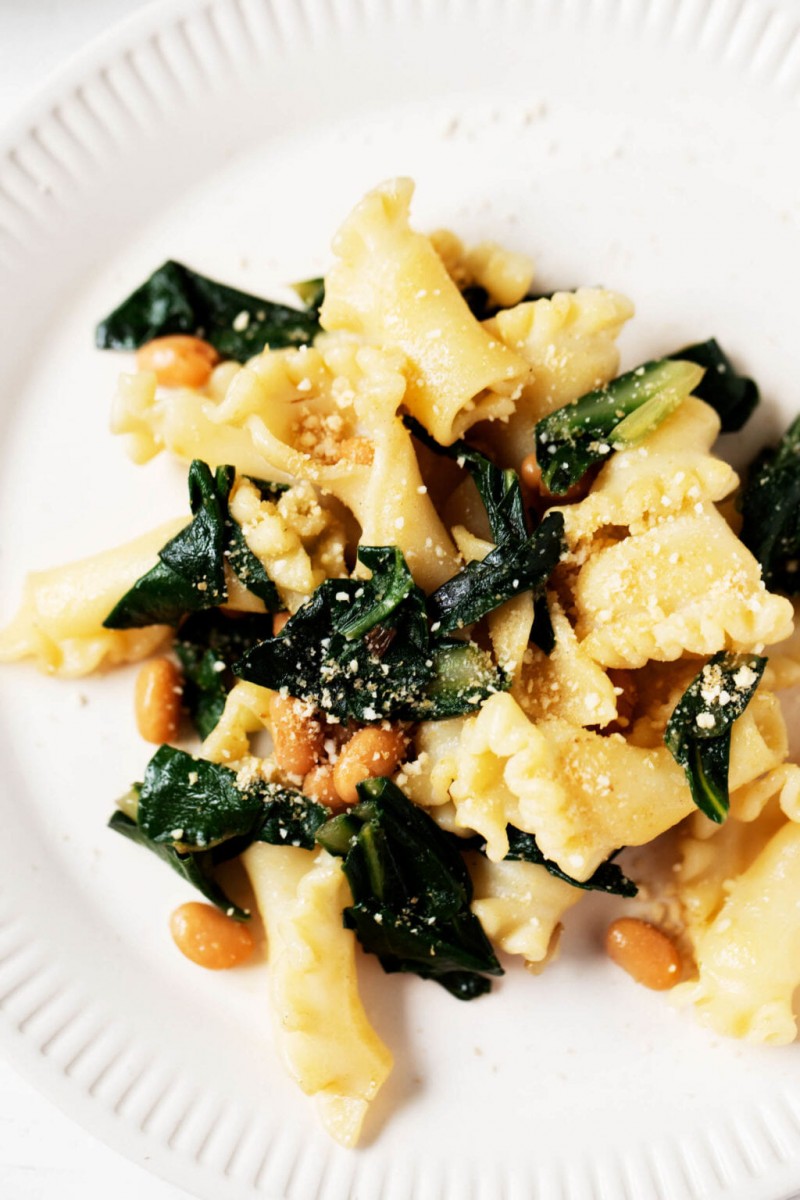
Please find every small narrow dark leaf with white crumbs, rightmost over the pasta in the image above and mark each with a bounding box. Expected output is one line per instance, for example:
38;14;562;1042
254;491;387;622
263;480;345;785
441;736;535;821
664;650;766;824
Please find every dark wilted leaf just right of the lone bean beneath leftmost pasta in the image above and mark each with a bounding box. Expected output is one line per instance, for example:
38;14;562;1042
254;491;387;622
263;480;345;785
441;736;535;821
174;608;272;738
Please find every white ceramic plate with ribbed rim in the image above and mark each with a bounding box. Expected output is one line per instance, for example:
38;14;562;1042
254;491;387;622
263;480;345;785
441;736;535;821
0;0;800;1200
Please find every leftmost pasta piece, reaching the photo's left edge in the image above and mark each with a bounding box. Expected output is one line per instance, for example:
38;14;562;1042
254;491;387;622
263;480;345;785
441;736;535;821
0;518;186;678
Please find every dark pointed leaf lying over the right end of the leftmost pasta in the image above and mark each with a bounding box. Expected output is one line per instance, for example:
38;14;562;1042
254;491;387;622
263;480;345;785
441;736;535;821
103;458;281;629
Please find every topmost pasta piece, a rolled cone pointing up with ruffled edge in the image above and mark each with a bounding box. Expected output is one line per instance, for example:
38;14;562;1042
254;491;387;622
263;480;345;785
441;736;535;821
320;179;529;445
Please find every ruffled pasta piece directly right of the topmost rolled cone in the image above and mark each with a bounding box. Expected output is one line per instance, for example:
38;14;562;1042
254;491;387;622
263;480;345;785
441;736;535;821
486;288;633;467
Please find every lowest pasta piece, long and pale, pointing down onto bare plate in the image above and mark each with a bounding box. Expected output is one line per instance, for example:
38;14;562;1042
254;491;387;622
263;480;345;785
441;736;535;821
242;842;392;1146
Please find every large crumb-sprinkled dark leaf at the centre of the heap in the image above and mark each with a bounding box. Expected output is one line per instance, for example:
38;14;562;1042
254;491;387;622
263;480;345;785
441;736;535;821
234;546;509;721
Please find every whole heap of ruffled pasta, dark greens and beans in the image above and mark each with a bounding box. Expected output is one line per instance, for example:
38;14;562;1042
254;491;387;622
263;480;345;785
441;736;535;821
0;179;800;1146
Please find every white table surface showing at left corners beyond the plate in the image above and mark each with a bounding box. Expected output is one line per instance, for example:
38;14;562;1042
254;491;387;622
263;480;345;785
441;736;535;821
0;0;187;1200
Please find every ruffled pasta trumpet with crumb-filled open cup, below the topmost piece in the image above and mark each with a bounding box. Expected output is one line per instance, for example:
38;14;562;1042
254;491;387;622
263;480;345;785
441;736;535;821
112;336;459;590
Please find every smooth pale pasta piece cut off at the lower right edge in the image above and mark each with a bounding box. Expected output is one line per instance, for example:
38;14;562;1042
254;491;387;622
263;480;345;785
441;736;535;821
676;821;800;1044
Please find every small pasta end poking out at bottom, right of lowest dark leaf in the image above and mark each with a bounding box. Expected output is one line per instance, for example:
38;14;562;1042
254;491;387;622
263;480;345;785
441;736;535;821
469;854;582;964
